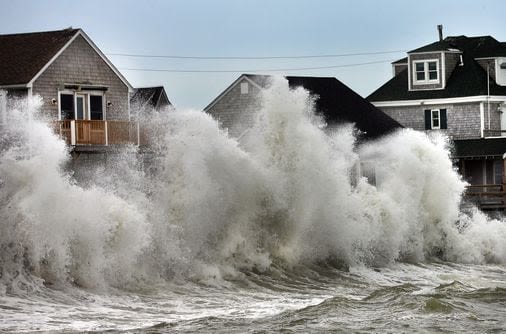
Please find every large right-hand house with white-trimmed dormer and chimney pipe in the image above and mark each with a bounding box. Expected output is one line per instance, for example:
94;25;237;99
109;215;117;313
367;27;506;190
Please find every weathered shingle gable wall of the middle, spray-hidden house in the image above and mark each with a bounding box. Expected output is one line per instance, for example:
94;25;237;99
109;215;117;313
206;79;261;137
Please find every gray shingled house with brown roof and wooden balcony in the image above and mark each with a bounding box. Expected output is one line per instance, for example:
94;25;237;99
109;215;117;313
0;28;139;150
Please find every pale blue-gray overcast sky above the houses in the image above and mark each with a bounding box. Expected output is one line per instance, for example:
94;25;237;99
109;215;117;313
0;0;506;109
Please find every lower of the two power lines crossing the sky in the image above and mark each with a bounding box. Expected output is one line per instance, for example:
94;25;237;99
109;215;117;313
119;59;395;73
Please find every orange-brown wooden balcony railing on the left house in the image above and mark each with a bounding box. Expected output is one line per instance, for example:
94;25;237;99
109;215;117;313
55;120;140;146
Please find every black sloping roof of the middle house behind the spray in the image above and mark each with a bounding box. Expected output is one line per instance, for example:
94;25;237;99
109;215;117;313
246;74;402;138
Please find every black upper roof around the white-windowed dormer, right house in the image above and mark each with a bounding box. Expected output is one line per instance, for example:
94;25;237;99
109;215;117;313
367;36;506;102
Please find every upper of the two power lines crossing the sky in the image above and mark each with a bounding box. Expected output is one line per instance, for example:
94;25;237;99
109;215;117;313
106;50;408;60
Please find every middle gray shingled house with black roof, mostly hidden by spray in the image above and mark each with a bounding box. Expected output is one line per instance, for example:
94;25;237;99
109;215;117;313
204;74;401;139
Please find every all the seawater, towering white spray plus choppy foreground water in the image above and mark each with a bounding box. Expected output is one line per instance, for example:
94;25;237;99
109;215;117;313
0;78;506;333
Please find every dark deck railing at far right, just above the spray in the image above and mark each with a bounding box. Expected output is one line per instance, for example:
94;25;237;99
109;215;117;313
465;184;506;210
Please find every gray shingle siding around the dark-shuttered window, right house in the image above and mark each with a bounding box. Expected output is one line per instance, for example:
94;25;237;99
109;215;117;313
380;103;490;139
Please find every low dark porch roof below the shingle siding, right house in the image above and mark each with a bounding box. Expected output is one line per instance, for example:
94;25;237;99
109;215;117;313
452;137;506;158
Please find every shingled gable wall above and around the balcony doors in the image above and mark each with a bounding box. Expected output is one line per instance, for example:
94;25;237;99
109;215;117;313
32;36;129;120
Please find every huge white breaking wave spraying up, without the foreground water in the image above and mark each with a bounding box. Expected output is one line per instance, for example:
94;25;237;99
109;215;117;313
0;79;506;293
